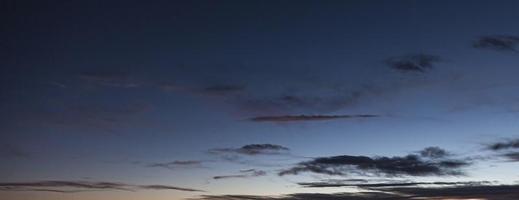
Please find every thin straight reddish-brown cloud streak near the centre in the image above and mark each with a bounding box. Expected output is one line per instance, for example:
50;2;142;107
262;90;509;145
249;114;379;122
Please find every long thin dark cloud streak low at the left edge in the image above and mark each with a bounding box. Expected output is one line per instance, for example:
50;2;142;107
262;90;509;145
0;181;203;193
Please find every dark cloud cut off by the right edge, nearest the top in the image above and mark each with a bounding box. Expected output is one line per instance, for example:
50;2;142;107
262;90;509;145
472;35;519;52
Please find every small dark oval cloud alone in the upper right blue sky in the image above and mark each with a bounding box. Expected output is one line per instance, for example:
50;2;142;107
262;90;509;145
386;54;441;72
